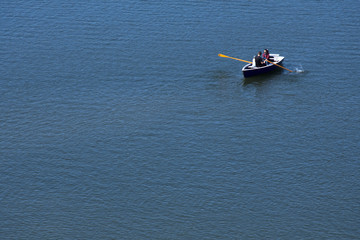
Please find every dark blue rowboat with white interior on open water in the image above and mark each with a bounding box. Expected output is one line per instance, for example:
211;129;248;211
242;54;285;78
